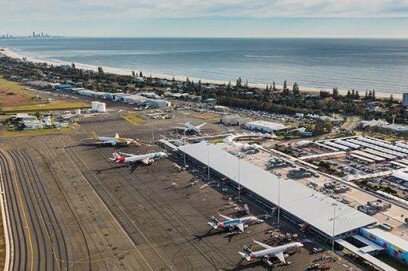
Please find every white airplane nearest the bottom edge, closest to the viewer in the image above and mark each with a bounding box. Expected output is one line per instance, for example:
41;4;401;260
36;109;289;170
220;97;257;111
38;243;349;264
239;240;303;266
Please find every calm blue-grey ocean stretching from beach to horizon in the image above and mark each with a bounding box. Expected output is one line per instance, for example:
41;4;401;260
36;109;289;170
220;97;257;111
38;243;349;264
0;38;408;93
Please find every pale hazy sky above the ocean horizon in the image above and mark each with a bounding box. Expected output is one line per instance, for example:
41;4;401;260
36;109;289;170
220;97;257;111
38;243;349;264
0;0;408;38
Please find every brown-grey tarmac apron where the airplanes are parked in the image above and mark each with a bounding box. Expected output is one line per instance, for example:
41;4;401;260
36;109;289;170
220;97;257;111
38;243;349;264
0;110;358;270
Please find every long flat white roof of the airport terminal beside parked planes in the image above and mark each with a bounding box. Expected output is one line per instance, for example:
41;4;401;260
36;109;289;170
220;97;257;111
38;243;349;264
179;141;377;237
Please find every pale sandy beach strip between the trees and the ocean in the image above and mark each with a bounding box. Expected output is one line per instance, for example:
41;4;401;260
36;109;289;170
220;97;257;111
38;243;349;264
0;47;403;101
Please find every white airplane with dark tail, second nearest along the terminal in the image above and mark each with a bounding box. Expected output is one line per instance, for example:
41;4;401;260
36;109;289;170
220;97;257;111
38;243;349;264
208;214;264;232
